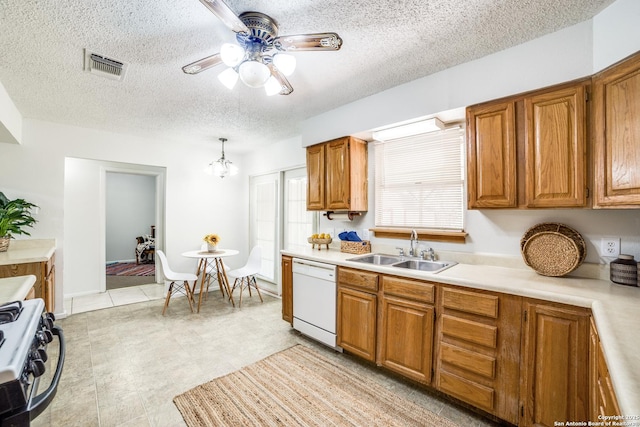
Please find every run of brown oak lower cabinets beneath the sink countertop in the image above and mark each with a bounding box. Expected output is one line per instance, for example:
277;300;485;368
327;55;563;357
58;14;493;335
283;261;620;426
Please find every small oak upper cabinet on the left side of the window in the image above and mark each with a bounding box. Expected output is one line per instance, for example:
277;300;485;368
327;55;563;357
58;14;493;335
307;136;368;212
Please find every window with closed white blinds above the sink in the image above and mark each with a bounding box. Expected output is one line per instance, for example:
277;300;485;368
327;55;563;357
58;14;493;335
374;128;464;231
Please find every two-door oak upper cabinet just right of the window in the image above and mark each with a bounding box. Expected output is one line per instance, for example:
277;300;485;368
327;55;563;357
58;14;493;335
467;79;590;209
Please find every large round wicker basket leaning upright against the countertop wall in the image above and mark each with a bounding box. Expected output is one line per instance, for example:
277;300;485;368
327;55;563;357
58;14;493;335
520;222;587;277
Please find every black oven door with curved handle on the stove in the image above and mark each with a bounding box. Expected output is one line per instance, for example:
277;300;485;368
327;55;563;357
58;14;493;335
0;326;66;427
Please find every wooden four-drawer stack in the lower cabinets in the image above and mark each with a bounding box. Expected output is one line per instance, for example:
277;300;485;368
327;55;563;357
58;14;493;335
434;286;522;424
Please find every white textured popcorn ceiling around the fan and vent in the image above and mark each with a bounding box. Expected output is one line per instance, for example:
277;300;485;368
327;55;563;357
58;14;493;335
0;0;613;152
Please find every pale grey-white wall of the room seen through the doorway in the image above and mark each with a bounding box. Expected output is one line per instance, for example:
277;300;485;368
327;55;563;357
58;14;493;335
105;172;156;262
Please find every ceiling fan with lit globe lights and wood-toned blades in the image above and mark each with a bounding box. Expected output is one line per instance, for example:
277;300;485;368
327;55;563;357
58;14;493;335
182;0;342;95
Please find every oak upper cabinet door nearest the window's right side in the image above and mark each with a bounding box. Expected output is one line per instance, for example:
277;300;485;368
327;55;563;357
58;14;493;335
467;102;517;209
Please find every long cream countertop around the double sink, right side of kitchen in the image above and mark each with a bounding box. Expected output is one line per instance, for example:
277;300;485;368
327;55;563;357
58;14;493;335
282;248;640;415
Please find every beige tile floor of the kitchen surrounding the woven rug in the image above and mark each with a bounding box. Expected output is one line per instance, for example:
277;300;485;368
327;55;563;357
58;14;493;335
32;288;504;427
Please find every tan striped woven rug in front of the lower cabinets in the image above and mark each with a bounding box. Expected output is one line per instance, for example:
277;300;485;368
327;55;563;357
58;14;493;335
173;345;457;427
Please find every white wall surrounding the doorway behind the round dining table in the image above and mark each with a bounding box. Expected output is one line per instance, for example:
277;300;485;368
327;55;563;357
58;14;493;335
0;119;248;314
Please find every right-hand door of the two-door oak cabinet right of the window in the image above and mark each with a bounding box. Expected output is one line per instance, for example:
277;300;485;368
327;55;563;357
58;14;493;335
524;84;586;208
